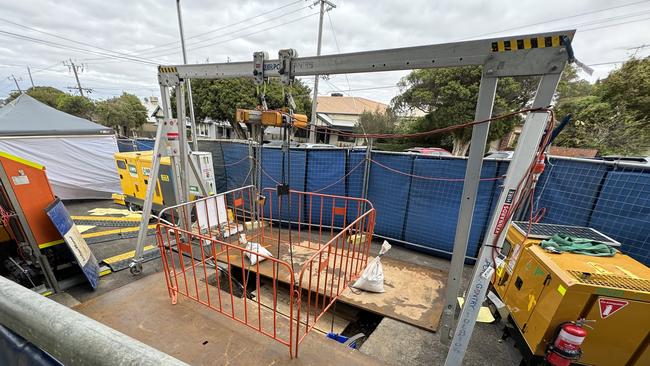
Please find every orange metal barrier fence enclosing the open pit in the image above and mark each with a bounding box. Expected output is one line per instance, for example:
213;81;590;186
157;186;375;357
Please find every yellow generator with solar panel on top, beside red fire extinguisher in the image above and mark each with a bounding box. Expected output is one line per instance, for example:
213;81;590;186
493;222;650;366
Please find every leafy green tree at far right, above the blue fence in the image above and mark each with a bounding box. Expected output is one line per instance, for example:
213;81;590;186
555;58;650;155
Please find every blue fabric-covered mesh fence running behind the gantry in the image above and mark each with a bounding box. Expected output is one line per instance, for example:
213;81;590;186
213;142;650;264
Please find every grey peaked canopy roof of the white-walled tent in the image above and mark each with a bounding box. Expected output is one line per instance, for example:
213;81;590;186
0;94;113;136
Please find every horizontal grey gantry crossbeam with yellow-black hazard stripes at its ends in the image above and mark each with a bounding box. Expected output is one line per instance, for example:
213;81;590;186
158;30;575;86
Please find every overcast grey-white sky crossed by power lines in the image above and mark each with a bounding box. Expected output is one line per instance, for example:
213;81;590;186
0;0;650;102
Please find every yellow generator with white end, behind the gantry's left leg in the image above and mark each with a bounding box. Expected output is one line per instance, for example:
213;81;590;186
110;151;215;211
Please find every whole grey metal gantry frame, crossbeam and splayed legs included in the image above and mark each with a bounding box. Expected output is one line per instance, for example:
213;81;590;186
132;30;575;365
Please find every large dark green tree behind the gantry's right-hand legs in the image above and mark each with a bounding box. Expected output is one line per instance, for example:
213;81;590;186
392;67;538;155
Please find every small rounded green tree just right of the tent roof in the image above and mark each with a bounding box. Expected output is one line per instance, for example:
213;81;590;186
96;93;147;136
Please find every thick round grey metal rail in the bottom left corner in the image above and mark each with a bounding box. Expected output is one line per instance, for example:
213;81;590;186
0;276;187;366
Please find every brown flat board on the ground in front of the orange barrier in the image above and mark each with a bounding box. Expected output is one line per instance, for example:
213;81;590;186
75;273;382;366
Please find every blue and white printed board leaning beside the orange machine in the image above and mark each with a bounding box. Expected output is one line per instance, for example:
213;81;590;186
45;198;99;289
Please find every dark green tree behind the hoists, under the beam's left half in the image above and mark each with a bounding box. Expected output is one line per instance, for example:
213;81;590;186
185;78;311;138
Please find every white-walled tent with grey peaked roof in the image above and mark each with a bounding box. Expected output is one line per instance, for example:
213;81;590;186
0;94;121;199
